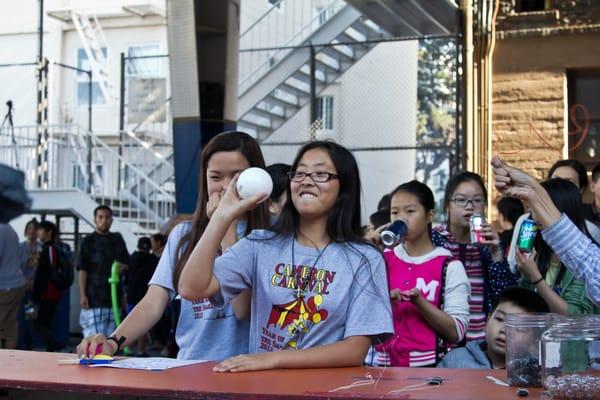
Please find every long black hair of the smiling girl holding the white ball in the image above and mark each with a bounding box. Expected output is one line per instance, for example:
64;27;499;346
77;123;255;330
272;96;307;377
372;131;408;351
272;141;366;243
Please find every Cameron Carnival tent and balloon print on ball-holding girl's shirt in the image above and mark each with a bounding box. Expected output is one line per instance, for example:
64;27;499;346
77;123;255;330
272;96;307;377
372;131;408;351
260;263;336;351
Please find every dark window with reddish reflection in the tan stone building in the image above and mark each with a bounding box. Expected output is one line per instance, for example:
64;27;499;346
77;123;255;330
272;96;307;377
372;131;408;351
567;70;600;170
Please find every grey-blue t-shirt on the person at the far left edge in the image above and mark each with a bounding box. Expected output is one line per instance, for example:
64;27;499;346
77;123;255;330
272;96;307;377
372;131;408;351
0;224;25;289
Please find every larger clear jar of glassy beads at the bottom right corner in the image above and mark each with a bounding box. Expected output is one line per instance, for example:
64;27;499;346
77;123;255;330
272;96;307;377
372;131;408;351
542;316;600;399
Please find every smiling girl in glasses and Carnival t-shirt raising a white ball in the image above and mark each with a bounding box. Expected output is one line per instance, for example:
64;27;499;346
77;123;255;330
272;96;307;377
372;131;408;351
179;141;393;372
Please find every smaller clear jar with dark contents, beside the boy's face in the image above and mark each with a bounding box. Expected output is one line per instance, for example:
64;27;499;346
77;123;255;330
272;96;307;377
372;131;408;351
505;313;561;386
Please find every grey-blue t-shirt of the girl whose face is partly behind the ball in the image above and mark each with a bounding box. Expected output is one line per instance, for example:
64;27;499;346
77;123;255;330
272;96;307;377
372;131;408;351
149;222;250;360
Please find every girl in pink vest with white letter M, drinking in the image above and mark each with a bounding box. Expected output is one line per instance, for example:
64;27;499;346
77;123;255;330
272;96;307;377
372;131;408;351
367;181;470;367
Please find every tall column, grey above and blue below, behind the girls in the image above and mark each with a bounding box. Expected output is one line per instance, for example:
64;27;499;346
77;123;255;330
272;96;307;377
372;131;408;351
167;0;239;213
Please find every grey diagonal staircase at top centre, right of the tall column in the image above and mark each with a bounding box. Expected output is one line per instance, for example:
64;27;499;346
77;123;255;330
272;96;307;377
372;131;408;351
238;0;388;142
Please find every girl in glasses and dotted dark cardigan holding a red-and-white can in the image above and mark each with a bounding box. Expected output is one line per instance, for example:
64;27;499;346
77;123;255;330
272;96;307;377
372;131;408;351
432;172;518;341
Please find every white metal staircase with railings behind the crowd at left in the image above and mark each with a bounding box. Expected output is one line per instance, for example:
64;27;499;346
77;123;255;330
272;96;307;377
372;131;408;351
0;125;175;245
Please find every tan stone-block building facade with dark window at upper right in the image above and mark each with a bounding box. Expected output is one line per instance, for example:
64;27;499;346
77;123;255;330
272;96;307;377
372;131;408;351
490;0;600;179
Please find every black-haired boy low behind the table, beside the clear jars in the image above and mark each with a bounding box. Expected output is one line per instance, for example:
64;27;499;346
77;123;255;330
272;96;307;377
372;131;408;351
437;287;550;369
